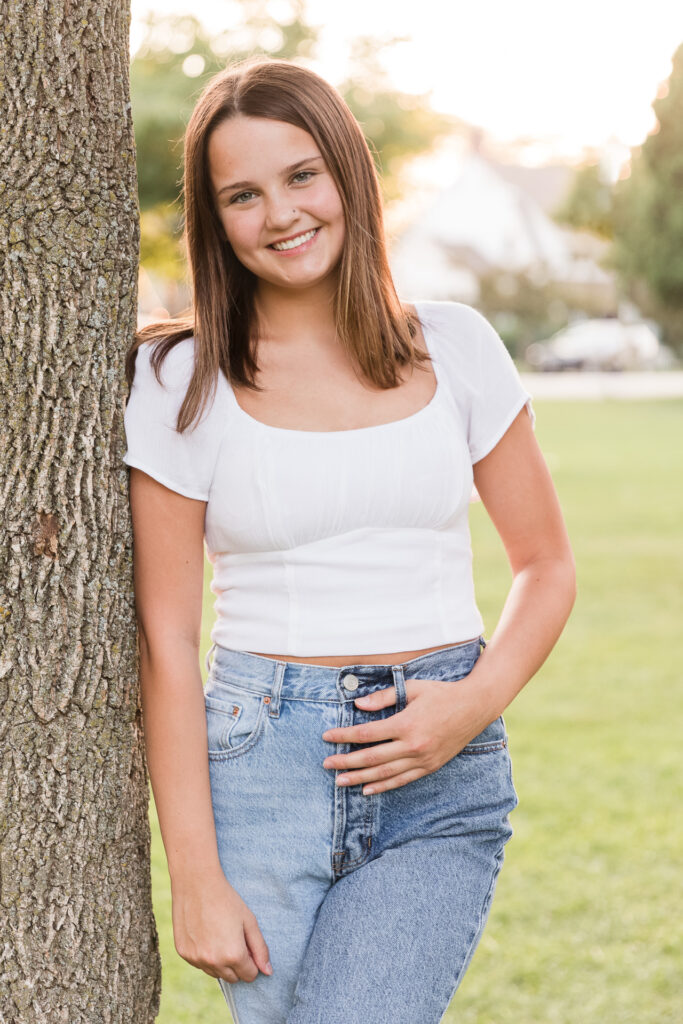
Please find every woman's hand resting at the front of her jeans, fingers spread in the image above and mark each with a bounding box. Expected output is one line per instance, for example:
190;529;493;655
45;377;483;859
323;674;497;794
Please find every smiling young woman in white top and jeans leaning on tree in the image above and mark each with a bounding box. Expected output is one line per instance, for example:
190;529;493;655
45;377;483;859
124;57;575;1024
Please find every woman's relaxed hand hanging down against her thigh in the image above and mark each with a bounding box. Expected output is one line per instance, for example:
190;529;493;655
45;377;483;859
172;872;272;982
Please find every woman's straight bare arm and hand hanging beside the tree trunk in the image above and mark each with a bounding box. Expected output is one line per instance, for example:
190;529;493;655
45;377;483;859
130;469;271;982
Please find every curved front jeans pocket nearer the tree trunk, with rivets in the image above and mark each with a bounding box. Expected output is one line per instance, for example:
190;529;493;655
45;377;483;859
204;680;267;761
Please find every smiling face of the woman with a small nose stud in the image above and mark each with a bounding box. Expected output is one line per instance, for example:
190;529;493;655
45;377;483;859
208;115;345;289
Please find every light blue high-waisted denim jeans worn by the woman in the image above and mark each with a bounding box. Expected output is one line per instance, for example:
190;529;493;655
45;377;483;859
205;637;517;1024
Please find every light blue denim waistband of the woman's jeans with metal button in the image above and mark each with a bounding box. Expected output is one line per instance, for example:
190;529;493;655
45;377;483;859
206;637;486;699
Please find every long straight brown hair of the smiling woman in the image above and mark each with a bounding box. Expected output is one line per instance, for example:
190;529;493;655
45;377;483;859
125;55;429;431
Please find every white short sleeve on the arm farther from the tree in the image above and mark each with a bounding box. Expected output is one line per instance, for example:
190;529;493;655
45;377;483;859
456;306;536;464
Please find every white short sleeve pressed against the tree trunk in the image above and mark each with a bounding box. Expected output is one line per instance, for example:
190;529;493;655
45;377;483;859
123;338;217;501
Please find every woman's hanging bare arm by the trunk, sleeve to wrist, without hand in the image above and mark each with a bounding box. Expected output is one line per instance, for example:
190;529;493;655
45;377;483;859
130;469;220;882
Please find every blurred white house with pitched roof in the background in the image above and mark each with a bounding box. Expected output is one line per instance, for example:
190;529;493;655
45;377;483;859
391;151;617;313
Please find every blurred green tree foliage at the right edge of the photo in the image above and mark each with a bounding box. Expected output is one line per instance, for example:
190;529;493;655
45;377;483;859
610;44;683;351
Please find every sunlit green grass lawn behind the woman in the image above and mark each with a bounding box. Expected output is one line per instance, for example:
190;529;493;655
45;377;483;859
151;400;683;1024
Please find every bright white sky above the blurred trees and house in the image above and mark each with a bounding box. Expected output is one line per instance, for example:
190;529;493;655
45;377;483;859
131;0;683;162
